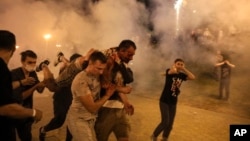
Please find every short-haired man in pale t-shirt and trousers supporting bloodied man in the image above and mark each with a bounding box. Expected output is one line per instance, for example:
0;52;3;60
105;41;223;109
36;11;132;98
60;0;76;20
67;51;115;141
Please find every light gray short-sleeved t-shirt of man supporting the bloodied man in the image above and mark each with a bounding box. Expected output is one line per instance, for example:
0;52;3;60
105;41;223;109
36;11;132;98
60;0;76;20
69;71;101;120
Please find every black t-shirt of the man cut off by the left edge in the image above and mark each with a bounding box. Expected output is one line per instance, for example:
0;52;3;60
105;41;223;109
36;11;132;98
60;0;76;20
0;58;15;141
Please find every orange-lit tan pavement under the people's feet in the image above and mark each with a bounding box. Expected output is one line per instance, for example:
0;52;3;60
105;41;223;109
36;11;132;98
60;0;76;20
24;87;250;141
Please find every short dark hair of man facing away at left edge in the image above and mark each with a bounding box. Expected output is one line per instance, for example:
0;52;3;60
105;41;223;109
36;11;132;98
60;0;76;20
0;30;16;51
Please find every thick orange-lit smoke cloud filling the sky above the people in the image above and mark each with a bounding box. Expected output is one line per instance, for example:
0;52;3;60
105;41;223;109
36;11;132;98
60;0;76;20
0;0;250;107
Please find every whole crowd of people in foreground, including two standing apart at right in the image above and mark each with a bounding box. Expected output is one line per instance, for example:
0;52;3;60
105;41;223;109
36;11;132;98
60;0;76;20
0;30;235;141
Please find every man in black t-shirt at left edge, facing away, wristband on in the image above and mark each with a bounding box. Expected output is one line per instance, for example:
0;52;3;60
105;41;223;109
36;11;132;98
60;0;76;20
0;30;42;141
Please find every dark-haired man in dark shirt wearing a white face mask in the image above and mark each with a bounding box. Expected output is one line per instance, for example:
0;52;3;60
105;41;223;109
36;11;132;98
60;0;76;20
11;50;45;141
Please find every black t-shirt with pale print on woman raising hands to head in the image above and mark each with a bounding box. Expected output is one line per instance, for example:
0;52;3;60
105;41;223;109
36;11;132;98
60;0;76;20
160;69;187;105
